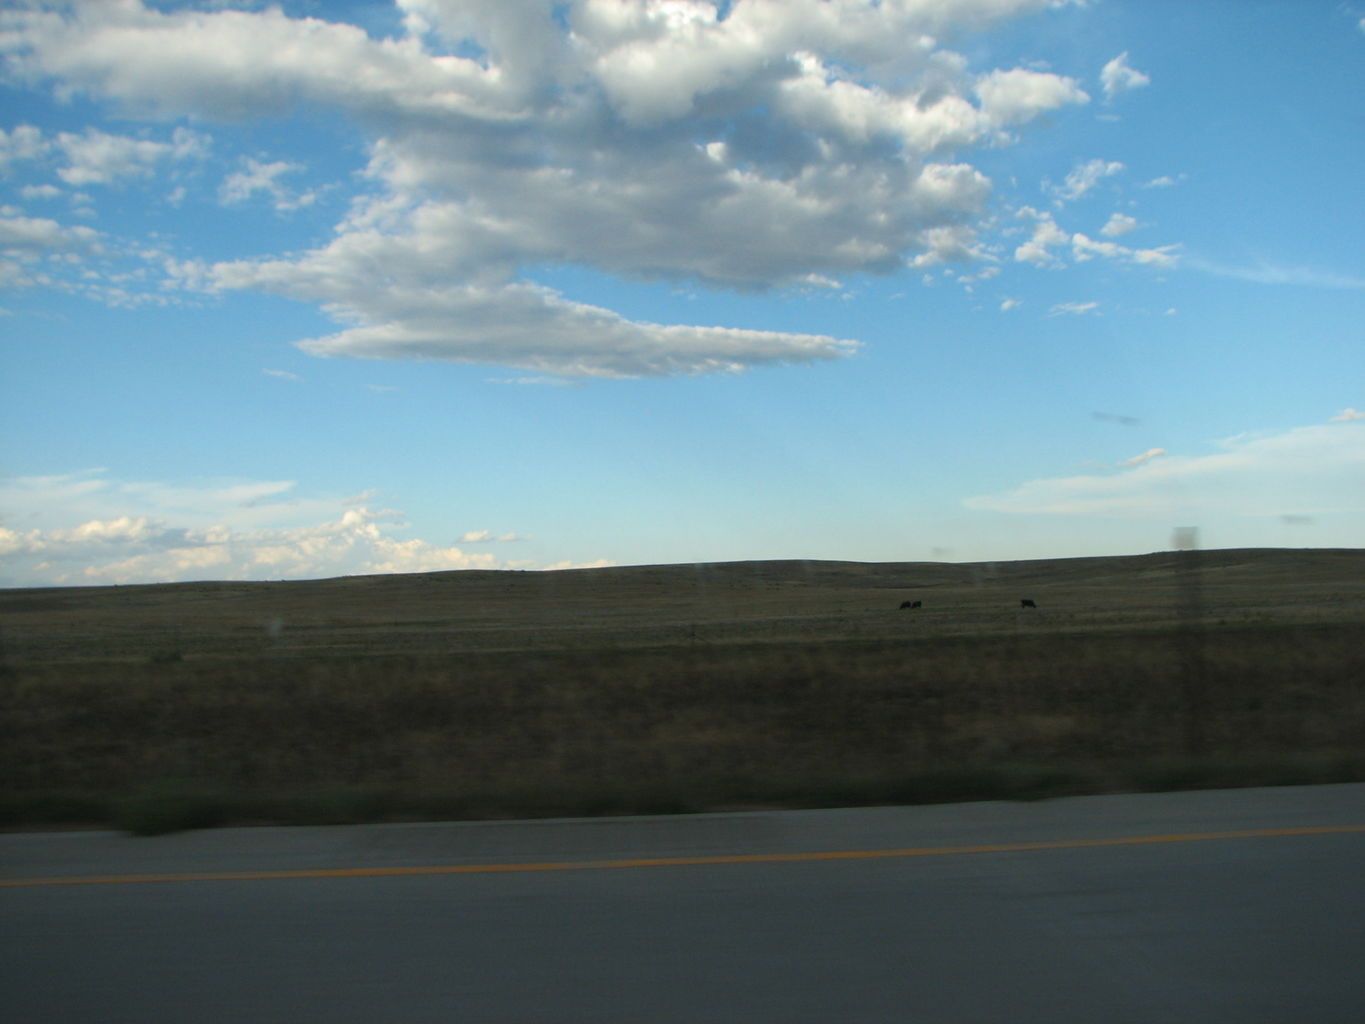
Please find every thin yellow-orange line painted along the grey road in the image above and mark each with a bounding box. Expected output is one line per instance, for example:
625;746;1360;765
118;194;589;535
0;825;1365;889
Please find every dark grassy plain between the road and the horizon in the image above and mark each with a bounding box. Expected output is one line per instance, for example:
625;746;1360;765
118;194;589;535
0;550;1365;833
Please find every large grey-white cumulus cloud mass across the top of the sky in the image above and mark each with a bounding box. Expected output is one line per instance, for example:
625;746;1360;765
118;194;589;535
0;0;1089;377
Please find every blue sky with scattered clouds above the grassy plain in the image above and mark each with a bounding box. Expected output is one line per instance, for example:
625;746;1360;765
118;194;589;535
0;0;1365;587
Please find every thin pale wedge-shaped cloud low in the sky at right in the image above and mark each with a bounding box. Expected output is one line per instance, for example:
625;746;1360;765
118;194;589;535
965;423;1365;519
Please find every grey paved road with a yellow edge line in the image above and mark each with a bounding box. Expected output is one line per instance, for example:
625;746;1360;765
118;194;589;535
8;785;1365;1024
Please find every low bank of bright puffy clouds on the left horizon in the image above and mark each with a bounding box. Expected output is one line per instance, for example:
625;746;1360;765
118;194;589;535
0;472;559;587
